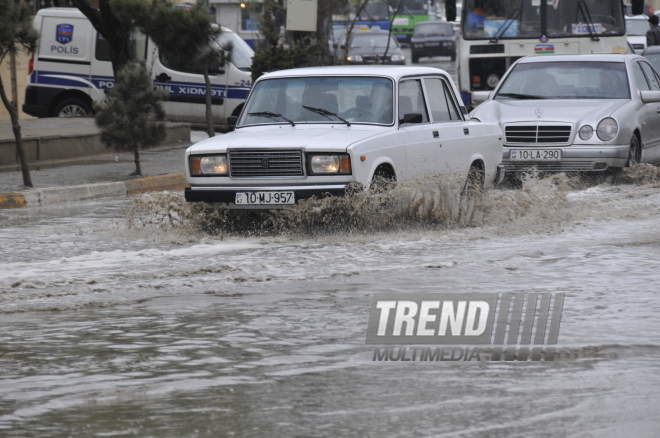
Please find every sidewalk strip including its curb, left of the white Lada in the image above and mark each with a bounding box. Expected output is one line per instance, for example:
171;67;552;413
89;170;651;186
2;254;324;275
0;131;207;209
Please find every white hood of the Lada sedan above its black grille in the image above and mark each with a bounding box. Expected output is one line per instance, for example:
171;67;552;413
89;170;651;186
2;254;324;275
190;125;392;154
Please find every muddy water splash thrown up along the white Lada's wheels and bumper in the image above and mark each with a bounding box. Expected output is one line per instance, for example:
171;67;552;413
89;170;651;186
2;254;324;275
127;174;572;237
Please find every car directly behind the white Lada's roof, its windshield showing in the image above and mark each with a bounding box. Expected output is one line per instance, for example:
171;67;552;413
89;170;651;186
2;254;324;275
335;29;406;65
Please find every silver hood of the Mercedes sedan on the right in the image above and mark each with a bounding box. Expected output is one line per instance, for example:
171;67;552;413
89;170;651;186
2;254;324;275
470;99;629;125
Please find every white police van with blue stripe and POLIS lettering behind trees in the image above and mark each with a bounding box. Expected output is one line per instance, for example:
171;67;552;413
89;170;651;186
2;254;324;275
23;8;254;129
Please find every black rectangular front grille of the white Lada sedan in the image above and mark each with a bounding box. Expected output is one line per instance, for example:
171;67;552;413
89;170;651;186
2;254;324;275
229;150;304;178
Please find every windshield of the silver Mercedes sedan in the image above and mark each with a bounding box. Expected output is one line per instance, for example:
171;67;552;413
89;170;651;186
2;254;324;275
495;61;630;100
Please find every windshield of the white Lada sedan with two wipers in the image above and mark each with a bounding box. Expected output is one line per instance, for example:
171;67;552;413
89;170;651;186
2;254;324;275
238;76;394;126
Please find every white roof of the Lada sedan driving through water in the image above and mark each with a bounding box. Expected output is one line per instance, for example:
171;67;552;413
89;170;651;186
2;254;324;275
259;65;447;80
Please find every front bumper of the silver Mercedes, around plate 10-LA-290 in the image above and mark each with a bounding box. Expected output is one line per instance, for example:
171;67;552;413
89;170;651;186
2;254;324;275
502;144;630;172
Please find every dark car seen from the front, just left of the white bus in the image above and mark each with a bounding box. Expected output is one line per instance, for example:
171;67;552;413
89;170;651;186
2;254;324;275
411;21;456;64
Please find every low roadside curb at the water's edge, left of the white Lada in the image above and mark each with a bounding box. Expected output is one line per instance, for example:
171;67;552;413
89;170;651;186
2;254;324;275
0;173;188;209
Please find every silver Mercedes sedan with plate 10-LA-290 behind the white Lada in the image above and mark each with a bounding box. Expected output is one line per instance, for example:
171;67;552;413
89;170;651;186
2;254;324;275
470;55;660;172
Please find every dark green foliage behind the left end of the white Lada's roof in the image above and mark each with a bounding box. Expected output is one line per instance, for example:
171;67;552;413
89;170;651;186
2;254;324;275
252;0;321;80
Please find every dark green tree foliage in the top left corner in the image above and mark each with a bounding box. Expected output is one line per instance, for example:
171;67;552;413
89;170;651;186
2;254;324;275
0;0;39;61
